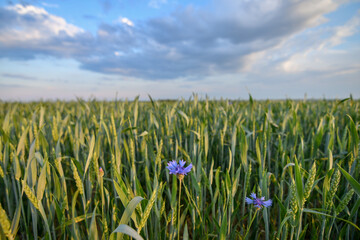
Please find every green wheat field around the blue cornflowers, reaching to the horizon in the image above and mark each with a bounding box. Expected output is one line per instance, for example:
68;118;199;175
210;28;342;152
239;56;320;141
0;95;360;240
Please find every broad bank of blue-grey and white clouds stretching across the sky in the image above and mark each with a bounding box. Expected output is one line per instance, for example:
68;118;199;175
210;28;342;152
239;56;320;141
0;0;359;80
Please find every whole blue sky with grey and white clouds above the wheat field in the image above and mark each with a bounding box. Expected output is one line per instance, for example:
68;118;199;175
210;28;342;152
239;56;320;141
0;0;360;101
